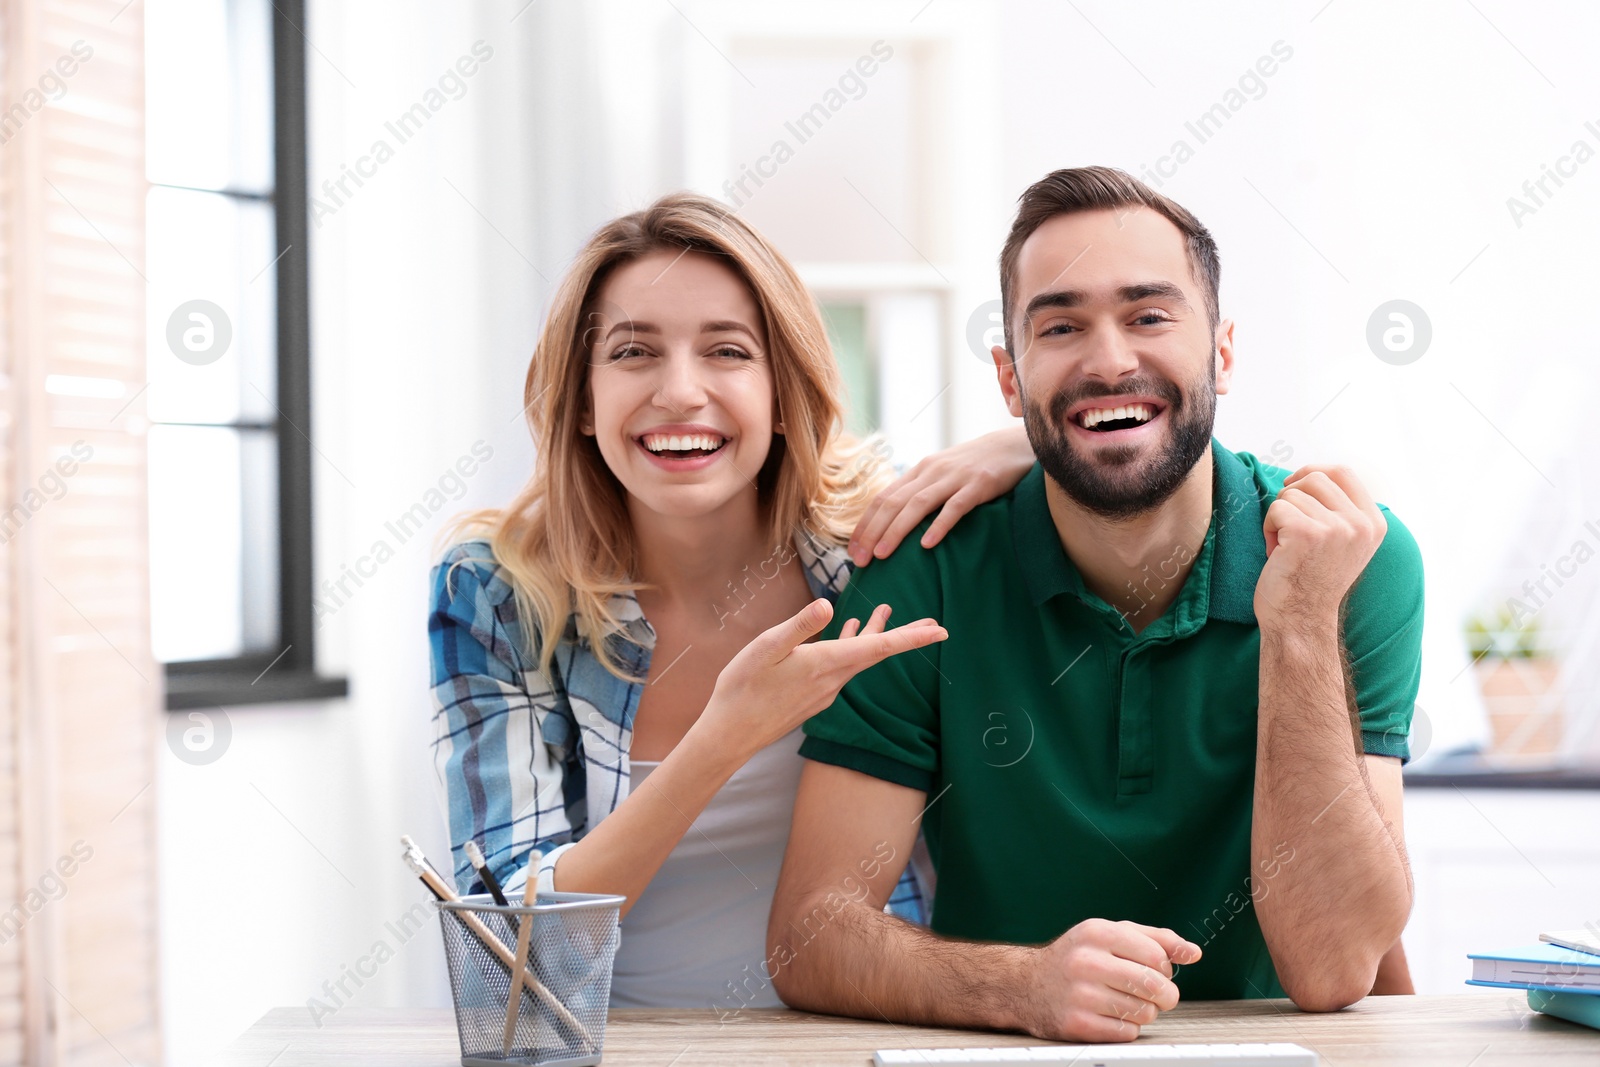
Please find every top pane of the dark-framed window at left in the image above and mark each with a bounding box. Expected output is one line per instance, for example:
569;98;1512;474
144;0;272;194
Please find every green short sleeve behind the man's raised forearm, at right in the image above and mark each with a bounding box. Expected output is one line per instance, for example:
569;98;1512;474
1344;509;1422;761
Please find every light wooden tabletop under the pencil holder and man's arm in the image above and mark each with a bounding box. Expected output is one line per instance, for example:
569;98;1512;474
222;990;1600;1067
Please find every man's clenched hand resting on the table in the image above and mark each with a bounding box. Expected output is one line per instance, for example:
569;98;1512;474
1021;918;1200;1041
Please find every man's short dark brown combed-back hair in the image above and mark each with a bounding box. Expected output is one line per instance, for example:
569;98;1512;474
1000;166;1222;351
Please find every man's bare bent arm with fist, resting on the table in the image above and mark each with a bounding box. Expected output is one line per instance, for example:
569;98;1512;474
774;761;1200;1041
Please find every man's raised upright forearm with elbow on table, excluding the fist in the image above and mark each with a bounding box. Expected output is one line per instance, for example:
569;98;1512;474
1251;619;1411;1009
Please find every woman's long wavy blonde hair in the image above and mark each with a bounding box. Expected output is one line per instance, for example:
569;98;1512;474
445;192;888;677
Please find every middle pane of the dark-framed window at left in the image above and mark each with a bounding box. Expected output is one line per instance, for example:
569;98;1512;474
146;189;277;422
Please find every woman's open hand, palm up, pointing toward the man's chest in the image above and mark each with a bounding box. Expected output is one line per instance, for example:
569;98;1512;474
691;600;949;763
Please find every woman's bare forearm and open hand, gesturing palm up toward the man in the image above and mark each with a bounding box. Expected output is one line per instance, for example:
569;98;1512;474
554;600;946;913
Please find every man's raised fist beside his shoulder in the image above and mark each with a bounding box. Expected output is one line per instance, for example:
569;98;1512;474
1256;467;1389;630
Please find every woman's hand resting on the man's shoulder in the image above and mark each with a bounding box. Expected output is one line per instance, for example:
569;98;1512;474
850;427;1034;566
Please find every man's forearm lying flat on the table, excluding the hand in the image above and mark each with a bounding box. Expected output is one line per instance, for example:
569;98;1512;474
768;894;1037;1030
